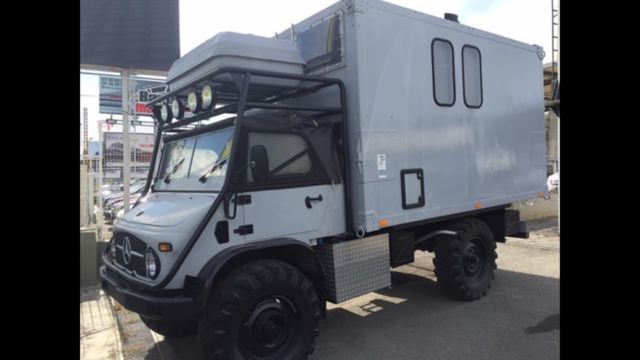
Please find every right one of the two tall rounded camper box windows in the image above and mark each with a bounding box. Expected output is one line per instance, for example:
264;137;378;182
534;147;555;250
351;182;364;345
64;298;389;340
462;45;482;108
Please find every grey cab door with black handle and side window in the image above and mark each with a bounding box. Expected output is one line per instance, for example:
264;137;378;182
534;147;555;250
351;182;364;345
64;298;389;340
239;132;345;242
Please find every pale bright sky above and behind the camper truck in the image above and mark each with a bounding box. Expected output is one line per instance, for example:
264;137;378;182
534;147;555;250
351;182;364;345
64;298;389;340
80;0;551;148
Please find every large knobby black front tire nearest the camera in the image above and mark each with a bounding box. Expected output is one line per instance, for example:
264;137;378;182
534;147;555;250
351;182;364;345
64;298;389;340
198;260;320;360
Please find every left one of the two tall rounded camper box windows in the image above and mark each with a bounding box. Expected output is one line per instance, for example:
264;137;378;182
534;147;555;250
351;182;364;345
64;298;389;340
431;39;456;106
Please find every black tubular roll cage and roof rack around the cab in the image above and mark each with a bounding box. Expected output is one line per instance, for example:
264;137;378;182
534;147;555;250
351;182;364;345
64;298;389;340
134;67;353;289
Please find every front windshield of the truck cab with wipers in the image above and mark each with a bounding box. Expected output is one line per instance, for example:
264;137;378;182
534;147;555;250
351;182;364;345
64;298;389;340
156;127;233;190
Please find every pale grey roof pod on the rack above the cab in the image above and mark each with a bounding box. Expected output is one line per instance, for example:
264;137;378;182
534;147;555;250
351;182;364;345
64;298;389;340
167;32;305;91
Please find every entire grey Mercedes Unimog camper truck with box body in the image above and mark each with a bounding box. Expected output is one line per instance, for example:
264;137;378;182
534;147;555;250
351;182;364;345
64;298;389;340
100;0;546;359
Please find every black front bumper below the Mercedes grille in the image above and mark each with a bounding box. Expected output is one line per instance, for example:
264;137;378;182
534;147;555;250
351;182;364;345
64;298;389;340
100;265;199;321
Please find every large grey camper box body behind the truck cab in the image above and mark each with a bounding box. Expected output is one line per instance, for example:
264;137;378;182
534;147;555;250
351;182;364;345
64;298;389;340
279;0;546;232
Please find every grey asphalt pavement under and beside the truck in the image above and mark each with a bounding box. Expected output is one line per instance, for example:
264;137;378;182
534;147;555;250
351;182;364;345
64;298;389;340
117;228;560;360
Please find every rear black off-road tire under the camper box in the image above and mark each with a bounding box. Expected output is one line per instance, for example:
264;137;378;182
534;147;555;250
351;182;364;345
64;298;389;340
433;218;498;300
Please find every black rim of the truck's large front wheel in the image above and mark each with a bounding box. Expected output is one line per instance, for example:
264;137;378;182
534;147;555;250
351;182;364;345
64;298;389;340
240;296;297;359
